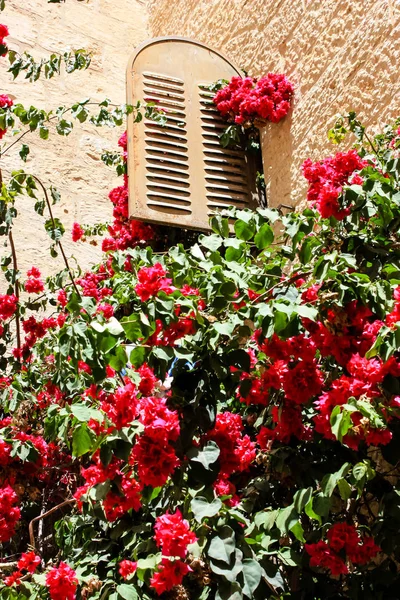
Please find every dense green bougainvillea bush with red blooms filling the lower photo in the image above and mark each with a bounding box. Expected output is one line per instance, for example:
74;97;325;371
0;4;400;600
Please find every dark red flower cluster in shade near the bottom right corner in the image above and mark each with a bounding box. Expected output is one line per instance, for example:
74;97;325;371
305;523;380;576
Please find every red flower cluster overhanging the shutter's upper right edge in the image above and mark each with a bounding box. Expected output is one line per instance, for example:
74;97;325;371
214;73;294;124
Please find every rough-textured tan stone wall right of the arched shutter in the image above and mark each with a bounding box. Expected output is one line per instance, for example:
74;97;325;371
148;0;400;205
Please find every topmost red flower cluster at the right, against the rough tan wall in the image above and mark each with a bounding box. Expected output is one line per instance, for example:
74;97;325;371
302;150;366;220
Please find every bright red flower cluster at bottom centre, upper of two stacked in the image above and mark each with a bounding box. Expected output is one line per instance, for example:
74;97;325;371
154;509;197;558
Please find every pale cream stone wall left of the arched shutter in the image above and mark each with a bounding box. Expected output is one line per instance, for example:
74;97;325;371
0;0;148;276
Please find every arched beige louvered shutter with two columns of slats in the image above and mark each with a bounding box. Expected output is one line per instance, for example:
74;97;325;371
127;38;256;230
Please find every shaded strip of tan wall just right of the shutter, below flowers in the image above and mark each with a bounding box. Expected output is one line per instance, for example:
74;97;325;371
261;108;295;207
